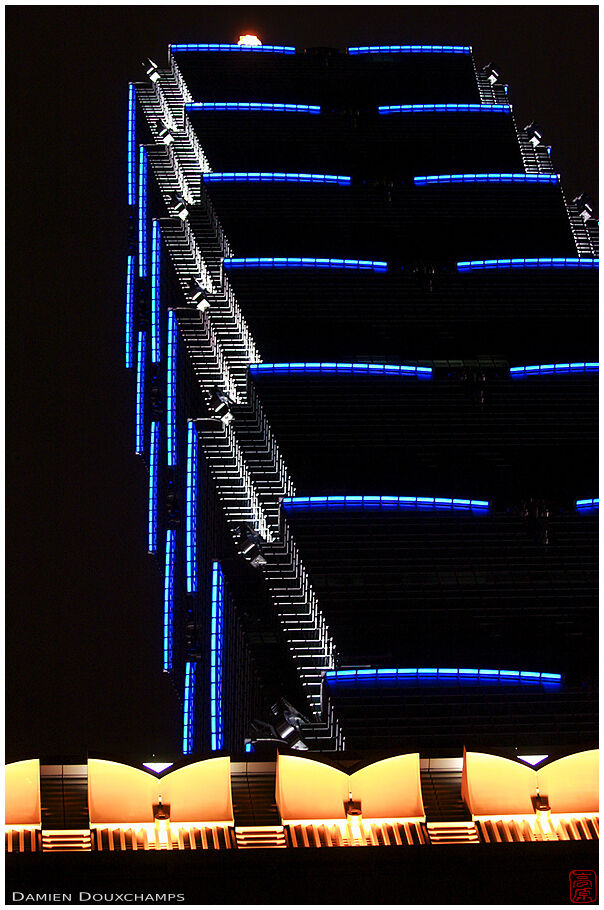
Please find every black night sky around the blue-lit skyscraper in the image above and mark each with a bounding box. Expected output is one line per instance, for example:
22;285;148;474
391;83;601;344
6;6;598;761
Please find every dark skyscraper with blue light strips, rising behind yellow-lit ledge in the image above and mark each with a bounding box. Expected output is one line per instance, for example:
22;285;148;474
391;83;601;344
125;43;599;756
